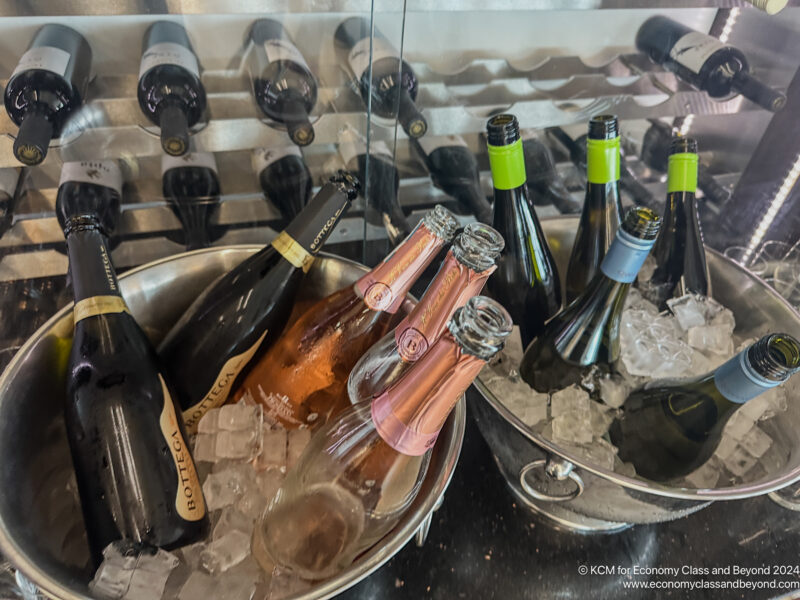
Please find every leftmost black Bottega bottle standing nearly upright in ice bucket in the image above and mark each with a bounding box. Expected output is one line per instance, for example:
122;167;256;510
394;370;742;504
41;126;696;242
56;161;208;564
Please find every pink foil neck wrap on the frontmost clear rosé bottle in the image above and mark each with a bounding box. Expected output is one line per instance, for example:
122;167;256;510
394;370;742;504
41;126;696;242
372;333;486;456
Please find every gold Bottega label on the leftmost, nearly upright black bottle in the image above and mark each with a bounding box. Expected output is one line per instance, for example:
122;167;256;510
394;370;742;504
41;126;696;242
158;374;206;521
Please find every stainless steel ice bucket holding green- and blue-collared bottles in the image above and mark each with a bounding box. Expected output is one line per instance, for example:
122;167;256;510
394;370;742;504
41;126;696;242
468;217;800;532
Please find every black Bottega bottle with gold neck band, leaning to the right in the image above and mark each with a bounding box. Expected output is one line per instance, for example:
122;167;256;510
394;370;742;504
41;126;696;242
158;172;359;433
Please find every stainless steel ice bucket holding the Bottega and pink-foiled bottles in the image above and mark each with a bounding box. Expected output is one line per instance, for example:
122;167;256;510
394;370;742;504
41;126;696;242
0;246;466;600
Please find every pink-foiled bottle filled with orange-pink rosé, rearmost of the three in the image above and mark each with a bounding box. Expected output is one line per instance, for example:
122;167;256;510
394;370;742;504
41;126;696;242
234;206;458;429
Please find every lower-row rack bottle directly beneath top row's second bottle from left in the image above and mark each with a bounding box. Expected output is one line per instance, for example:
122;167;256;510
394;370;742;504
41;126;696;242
161;152;220;250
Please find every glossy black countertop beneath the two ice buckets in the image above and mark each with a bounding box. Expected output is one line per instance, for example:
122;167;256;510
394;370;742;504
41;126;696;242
340;390;800;600
